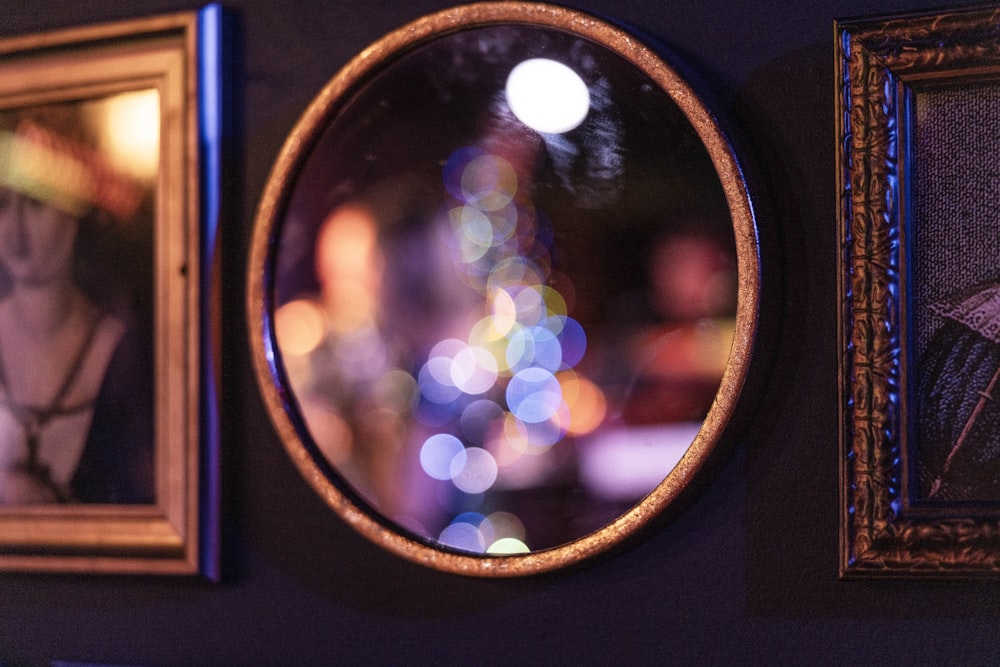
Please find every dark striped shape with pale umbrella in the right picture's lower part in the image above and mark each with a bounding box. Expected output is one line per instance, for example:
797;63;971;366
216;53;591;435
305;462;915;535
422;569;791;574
917;283;1000;501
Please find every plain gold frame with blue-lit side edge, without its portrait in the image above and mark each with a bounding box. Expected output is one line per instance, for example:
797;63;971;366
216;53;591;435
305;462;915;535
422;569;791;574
0;5;222;579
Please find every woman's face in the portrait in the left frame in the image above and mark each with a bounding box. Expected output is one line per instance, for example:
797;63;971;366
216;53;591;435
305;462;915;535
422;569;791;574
0;187;79;286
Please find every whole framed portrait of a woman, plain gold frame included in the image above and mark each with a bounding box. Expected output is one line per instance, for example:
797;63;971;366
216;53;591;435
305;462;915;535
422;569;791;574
0;6;222;578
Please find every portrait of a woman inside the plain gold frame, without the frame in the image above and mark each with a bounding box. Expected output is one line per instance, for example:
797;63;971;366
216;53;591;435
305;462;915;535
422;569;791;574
0;89;160;506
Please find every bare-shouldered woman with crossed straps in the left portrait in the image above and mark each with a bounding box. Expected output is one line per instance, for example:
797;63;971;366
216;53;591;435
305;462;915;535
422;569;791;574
0;104;153;504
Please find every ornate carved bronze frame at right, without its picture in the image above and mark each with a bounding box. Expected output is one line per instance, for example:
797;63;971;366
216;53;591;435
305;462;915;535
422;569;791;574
835;9;1000;579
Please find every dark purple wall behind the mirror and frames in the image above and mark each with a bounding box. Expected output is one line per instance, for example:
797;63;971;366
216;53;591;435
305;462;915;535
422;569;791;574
0;0;1000;665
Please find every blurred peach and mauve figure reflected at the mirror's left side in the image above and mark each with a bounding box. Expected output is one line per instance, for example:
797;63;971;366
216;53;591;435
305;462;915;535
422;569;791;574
277;185;468;522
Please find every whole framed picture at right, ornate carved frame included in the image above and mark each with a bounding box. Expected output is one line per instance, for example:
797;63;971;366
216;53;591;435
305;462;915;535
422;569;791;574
837;9;1000;578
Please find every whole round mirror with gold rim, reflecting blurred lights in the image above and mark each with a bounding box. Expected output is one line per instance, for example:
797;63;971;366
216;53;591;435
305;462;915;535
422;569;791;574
248;3;758;576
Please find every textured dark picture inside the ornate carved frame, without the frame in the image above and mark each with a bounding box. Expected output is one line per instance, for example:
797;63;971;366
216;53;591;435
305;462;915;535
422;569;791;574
910;80;1000;502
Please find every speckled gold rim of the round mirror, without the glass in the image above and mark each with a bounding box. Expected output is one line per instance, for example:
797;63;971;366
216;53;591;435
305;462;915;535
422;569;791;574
247;2;760;577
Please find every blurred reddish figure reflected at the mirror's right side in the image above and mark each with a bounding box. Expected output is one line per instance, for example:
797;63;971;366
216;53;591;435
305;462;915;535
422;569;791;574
622;232;736;424
